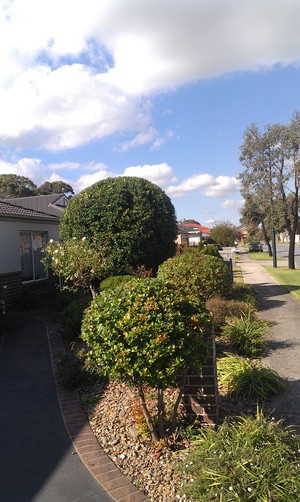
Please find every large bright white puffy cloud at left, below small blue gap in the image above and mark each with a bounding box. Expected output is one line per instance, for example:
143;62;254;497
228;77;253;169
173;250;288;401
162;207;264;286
0;64;149;151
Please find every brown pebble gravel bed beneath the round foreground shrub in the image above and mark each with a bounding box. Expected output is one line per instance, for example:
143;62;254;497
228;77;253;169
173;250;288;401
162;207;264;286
80;382;256;502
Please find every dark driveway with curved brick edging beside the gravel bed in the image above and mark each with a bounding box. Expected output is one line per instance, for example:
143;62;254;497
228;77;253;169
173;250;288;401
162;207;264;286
0;314;147;502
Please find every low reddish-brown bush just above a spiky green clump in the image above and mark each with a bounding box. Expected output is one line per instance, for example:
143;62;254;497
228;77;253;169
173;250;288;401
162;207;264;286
206;296;253;326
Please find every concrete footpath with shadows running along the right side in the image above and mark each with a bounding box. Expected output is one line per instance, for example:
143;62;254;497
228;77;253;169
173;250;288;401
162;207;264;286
237;253;300;432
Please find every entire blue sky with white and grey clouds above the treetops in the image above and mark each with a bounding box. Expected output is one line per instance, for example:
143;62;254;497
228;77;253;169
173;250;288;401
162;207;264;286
0;0;300;226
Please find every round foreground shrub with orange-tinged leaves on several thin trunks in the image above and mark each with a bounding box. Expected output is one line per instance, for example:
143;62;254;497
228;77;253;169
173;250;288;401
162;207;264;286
82;278;212;441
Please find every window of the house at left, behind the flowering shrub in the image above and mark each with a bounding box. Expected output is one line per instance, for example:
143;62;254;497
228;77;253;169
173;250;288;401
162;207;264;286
20;232;48;281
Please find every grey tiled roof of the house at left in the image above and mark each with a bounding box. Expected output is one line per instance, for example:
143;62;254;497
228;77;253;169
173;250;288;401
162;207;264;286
2;193;69;218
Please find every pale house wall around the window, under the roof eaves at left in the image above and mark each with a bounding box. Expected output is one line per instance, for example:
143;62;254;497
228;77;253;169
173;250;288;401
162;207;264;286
0;218;59;274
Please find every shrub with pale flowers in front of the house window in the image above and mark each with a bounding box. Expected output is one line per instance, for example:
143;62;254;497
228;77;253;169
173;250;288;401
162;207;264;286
43;237;108;297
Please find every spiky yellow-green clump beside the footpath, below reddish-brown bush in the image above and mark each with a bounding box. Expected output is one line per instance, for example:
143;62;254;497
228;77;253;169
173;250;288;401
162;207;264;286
221;311;270;358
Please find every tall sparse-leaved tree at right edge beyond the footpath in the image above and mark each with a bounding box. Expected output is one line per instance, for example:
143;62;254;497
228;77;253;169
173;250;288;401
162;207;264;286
239;112;300;269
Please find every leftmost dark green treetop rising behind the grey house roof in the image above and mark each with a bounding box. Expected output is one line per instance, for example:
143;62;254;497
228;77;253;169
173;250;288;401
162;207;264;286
0;174;37;199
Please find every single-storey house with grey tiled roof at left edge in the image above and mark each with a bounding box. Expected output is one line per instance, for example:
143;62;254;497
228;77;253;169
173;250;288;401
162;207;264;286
0;194;68;308
